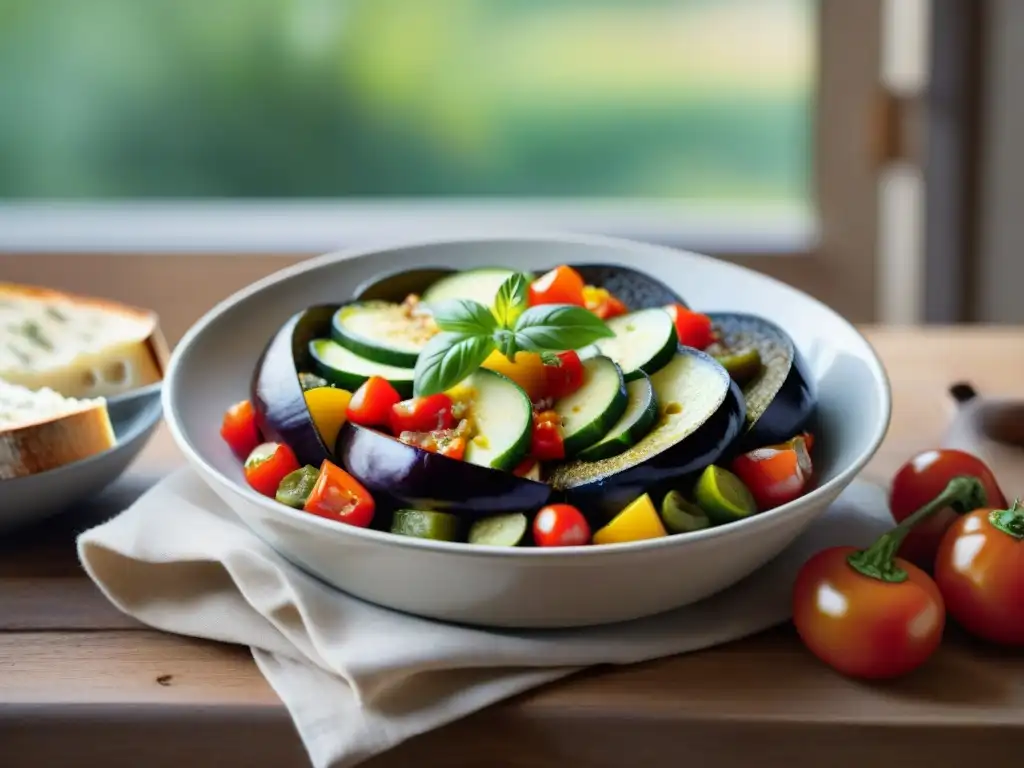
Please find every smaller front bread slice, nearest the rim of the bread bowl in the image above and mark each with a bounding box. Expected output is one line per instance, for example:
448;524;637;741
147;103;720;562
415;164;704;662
0;380;117;481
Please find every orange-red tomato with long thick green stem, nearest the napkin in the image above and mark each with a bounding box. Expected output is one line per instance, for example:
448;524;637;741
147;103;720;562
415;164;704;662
793;476;984;679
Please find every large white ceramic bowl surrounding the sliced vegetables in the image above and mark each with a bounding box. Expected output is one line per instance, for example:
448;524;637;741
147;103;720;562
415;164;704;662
164;236;890;628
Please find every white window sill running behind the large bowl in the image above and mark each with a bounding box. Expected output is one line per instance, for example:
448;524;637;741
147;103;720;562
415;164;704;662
0;200;818;254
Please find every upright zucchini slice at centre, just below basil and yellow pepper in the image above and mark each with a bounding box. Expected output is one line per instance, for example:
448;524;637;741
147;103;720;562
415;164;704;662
463;368;534;470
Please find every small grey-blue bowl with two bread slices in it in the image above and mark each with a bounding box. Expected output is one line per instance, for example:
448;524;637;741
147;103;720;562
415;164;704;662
0;283;168;532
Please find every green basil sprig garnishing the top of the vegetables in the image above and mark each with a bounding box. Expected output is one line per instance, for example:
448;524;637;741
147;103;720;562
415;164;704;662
414;272;614;395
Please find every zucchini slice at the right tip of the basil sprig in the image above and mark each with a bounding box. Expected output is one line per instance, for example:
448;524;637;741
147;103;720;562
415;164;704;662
594;307;679;381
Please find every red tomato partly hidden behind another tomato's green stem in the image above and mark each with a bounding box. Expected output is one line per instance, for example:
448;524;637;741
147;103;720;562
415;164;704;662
889;449;1007;571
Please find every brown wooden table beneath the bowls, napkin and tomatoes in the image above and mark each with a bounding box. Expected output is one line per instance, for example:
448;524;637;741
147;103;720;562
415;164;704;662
0;329;1024;768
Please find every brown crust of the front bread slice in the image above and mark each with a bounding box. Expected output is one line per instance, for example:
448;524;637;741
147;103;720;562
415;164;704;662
0;402;117;481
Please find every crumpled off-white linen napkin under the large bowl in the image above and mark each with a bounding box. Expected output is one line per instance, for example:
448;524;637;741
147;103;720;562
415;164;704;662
78;468;892;768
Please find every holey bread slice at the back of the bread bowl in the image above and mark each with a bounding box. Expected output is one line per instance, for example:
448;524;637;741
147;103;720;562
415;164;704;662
0;283;167;398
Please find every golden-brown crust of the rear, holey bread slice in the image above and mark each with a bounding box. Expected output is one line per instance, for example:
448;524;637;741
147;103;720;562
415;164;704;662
0;283;170;398
